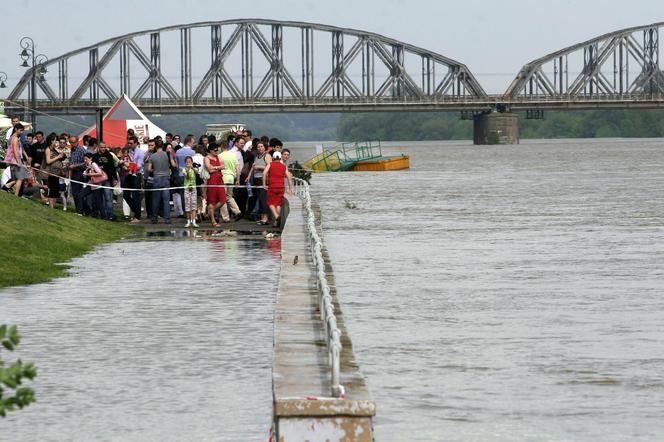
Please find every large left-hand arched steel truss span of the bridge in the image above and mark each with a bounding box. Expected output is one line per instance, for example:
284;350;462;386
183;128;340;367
6;19;482;112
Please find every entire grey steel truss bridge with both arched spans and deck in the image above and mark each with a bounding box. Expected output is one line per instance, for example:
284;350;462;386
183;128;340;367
6;19;664;113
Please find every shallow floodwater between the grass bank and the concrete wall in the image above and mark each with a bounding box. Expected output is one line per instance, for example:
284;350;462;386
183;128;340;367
0;237;280;441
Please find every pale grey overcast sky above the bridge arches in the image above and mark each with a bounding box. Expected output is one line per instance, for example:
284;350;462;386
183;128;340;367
0;0;664;97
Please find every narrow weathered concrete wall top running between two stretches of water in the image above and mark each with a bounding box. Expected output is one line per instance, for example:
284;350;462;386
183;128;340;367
272;198;376;441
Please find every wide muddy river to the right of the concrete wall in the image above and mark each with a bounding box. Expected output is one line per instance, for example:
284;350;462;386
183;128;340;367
294;139;664;442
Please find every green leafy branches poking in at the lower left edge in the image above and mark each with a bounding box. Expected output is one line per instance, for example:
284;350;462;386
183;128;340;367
0;324;37;417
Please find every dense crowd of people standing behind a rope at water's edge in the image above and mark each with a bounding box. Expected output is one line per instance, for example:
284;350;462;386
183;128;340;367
2;117;293;227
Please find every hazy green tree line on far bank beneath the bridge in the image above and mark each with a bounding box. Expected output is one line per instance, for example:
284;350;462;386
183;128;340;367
33;109;664;141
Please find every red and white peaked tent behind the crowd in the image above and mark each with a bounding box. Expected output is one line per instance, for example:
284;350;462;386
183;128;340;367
79;95;166;147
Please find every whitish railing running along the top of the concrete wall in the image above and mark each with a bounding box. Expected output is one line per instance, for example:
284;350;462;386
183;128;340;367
293;178;344;398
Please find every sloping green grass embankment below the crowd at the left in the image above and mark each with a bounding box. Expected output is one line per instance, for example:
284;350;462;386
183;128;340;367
0;192;136;287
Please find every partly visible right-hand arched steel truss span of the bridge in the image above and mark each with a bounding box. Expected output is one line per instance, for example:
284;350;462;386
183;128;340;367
504;22;664;101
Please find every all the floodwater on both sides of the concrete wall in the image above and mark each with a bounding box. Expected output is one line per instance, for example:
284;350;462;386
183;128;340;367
0;140;664;442
